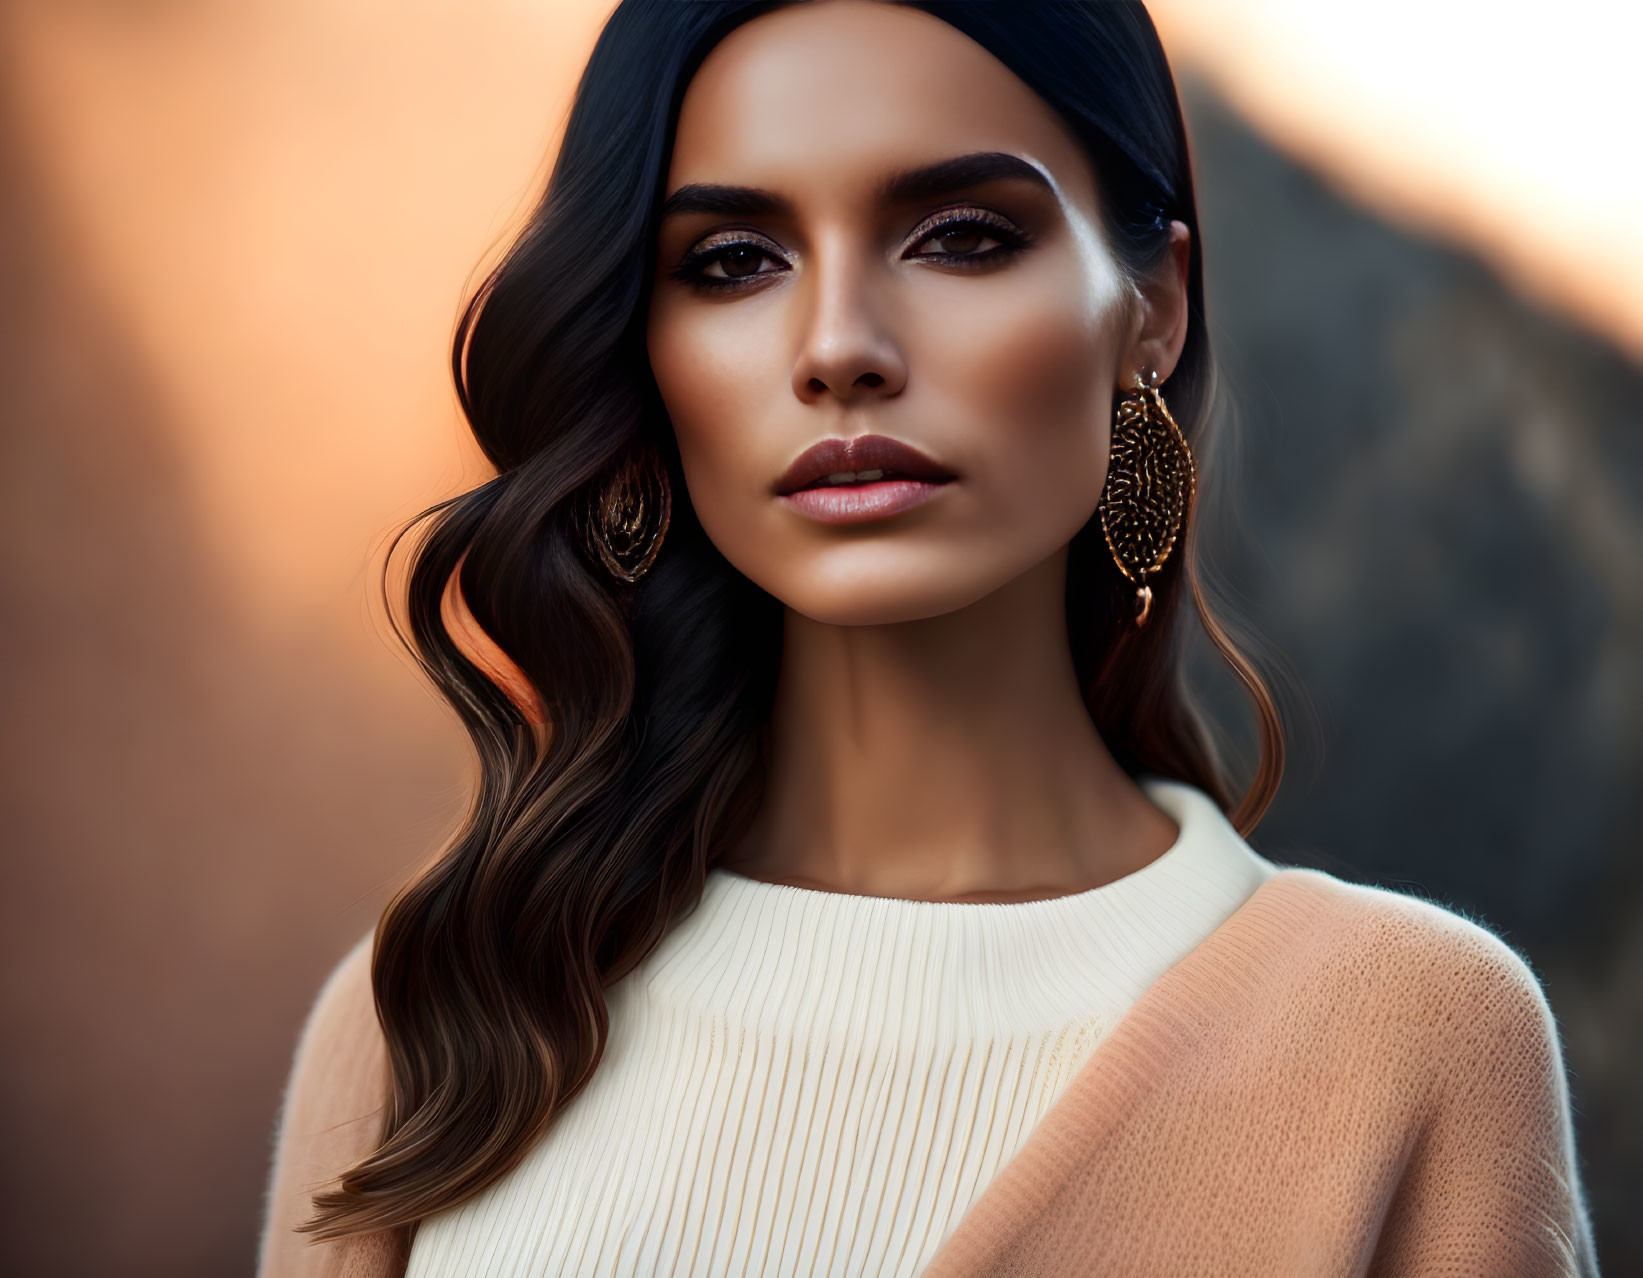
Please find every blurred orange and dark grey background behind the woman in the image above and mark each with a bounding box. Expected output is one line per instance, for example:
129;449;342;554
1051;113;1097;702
0;0;1643;1278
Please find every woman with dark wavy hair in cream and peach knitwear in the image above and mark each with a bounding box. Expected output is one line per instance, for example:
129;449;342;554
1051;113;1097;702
263;0;1595;1276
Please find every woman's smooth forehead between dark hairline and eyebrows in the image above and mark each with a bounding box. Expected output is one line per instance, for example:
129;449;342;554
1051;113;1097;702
669;0;1093;204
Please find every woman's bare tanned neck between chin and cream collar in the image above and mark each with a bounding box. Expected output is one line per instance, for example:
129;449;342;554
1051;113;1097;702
720;549;1180;900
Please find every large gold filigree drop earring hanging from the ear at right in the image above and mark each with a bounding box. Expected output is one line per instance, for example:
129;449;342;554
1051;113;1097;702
1096;370;1198;626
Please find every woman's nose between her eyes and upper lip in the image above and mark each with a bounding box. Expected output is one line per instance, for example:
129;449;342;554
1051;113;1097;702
790;239;907;402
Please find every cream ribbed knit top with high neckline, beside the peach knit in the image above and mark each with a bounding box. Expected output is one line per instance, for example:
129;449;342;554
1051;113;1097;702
407;777;1278;1278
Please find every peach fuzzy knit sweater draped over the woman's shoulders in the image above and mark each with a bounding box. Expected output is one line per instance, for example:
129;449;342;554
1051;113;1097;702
263;867;1597;1278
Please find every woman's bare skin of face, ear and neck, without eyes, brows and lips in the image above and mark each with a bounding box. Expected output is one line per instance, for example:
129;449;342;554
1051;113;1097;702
647;0;1190;902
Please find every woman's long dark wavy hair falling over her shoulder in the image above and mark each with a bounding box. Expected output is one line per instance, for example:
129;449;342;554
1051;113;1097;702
302;0;1283;1239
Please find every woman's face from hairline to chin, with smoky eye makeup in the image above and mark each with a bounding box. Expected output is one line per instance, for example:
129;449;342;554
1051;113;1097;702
647;0;1143;624
